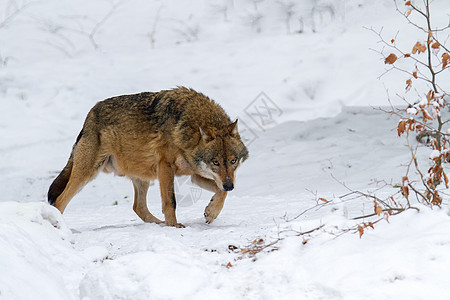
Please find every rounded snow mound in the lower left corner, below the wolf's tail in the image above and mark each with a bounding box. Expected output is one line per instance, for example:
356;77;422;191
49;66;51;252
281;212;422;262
0;202;88;299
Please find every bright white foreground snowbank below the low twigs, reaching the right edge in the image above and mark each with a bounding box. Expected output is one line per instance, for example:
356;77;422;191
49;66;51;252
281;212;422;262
81;209;450;299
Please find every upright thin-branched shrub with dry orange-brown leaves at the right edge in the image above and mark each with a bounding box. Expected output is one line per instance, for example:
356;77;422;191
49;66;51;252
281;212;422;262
370;0;450;205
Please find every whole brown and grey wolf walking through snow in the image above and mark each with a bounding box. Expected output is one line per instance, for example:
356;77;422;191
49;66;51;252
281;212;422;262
48;87;248;227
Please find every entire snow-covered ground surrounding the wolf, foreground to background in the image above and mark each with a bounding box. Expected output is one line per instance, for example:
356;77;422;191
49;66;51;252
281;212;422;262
0;0;450;300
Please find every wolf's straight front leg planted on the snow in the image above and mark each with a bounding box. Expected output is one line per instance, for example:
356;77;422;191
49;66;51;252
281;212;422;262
158;161;184;228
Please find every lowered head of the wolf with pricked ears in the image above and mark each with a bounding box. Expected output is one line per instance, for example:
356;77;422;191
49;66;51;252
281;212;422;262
193;120;248;191
